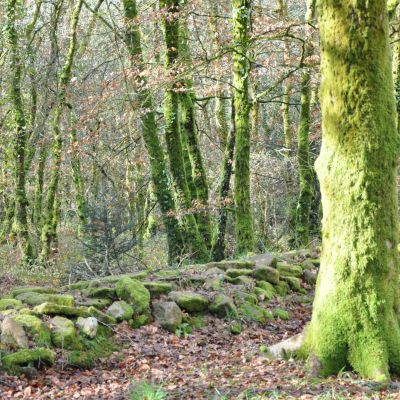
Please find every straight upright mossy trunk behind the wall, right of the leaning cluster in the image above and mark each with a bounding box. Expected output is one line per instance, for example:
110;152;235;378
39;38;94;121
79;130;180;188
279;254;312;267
233;0;254;254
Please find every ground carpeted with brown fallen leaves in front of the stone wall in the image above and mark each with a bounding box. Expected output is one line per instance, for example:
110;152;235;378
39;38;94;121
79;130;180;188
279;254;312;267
0;282;400;400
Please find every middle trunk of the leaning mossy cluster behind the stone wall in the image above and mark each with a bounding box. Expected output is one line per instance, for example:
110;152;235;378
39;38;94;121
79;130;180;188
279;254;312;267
160;0;209;260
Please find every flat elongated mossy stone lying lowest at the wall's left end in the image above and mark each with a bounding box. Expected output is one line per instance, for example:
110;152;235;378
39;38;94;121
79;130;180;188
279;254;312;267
1;347;55;372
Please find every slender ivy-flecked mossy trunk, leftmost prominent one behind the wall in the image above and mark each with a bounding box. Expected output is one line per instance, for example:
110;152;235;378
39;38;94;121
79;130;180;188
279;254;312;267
5;0;34;263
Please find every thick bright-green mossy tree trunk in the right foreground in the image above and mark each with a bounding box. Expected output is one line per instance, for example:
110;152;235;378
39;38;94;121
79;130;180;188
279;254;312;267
304;0;400;381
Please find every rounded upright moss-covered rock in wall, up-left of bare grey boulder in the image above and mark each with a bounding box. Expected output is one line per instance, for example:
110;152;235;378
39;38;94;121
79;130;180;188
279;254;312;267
115;277;150;314
